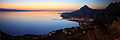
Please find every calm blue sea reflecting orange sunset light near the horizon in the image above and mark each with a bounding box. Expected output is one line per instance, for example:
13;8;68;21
0;11;78;36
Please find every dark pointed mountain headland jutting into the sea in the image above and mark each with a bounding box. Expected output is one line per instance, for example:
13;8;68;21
61;5;103;18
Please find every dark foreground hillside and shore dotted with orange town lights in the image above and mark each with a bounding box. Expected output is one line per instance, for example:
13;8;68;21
0;2;120;40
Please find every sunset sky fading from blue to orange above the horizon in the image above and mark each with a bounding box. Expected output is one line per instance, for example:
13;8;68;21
0;0;118;10
